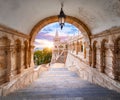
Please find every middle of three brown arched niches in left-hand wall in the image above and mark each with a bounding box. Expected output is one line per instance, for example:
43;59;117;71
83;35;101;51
15;39;21;74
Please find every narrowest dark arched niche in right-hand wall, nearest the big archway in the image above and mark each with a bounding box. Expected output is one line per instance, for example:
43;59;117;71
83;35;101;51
92;41;97;68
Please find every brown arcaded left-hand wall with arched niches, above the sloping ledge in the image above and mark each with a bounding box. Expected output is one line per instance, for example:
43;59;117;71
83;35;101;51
0;26;30;85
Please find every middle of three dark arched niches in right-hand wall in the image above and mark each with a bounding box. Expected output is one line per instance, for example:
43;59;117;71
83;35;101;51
100;39;108;73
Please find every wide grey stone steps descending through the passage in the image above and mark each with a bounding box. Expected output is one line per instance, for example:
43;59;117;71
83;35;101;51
0;64;120;100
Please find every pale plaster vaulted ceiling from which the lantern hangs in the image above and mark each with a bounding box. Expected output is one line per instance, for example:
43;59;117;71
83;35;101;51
0;0;120;34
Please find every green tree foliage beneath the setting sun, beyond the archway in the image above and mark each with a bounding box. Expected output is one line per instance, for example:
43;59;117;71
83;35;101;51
34;48;52;65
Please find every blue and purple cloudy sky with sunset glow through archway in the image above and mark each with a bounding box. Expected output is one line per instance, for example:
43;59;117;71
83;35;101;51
34;22;81;49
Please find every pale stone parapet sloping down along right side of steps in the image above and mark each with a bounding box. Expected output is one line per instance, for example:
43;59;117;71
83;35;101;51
66;53;120;92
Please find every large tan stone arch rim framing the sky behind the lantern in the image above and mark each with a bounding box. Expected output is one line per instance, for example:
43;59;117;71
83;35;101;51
29;16;91;66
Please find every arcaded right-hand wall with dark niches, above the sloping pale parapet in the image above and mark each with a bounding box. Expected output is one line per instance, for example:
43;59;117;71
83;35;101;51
91;27;120;80
